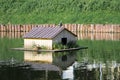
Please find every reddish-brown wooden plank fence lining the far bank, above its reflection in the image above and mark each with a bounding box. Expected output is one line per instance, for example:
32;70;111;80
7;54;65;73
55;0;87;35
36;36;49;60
0;24;120;34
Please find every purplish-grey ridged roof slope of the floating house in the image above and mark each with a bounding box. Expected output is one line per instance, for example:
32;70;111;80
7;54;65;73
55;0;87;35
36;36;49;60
23;27;65;38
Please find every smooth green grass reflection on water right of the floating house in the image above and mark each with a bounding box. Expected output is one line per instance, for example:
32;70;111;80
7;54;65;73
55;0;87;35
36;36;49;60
78;40;120;62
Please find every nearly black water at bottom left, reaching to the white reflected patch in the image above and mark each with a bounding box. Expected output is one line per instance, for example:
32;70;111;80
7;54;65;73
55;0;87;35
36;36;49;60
0;62;60;80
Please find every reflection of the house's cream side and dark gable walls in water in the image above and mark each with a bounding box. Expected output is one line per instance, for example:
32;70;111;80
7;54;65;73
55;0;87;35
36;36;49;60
24;51;76;69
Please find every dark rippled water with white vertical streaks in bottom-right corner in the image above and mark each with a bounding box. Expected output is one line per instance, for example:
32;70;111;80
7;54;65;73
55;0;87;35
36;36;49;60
74;61;120;80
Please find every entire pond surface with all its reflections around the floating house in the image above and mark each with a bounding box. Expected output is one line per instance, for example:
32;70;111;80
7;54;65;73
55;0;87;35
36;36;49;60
0;33;120;80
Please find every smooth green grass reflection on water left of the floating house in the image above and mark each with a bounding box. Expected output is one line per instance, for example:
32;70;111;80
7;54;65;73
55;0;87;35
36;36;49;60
0;38;24;61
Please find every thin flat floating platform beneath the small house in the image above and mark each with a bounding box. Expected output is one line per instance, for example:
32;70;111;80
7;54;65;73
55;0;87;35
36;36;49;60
11;47;88;52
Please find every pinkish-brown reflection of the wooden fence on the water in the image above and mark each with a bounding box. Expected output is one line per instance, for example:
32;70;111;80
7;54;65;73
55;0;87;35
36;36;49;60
0;32;120;40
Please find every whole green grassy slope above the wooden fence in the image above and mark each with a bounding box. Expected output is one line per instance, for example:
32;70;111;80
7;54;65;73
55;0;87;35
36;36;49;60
0;0;120;24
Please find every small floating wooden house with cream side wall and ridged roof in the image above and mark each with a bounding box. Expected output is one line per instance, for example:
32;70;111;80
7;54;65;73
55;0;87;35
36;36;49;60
24;27;77;49
